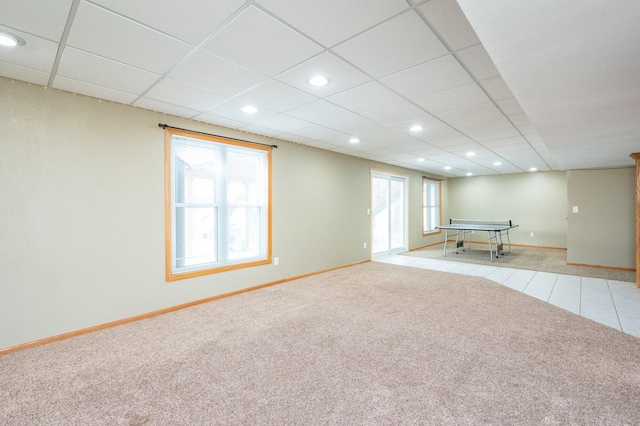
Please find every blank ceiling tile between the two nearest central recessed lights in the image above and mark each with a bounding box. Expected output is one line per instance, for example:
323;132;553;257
238;80;318;112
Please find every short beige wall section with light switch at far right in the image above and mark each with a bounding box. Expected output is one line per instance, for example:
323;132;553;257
567;167;636;268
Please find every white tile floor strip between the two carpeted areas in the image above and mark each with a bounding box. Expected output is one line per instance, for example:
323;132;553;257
373;255;640;338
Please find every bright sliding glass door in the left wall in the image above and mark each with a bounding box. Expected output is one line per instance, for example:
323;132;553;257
371;171;408;257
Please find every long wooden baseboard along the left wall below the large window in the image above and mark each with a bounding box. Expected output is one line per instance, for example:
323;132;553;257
0;260;370;356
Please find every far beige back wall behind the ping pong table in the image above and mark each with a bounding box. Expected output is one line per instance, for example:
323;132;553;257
444;172;567;248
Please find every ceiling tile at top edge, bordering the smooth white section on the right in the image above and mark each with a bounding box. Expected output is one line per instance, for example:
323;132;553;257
420;0;480;50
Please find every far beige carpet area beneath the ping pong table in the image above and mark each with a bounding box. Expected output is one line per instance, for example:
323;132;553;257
402;242;636;282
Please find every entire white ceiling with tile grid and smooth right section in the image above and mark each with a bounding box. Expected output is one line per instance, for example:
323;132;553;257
0;0;640;177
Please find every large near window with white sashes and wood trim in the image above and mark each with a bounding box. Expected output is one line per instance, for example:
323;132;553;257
165;128;271;281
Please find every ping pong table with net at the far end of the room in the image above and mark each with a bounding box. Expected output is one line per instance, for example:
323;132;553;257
436;219;518;262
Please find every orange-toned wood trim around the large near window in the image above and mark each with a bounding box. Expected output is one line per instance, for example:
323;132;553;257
164;127;272;281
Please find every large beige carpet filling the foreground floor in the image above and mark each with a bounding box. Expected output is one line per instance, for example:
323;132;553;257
0;262;640;425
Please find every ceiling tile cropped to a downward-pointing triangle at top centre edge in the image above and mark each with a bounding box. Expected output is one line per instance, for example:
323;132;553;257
257;0;408;47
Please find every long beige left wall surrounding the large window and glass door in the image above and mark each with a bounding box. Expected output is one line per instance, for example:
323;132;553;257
0;78;439;349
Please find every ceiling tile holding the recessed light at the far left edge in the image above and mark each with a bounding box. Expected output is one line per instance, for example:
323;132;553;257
0;28;58;73
